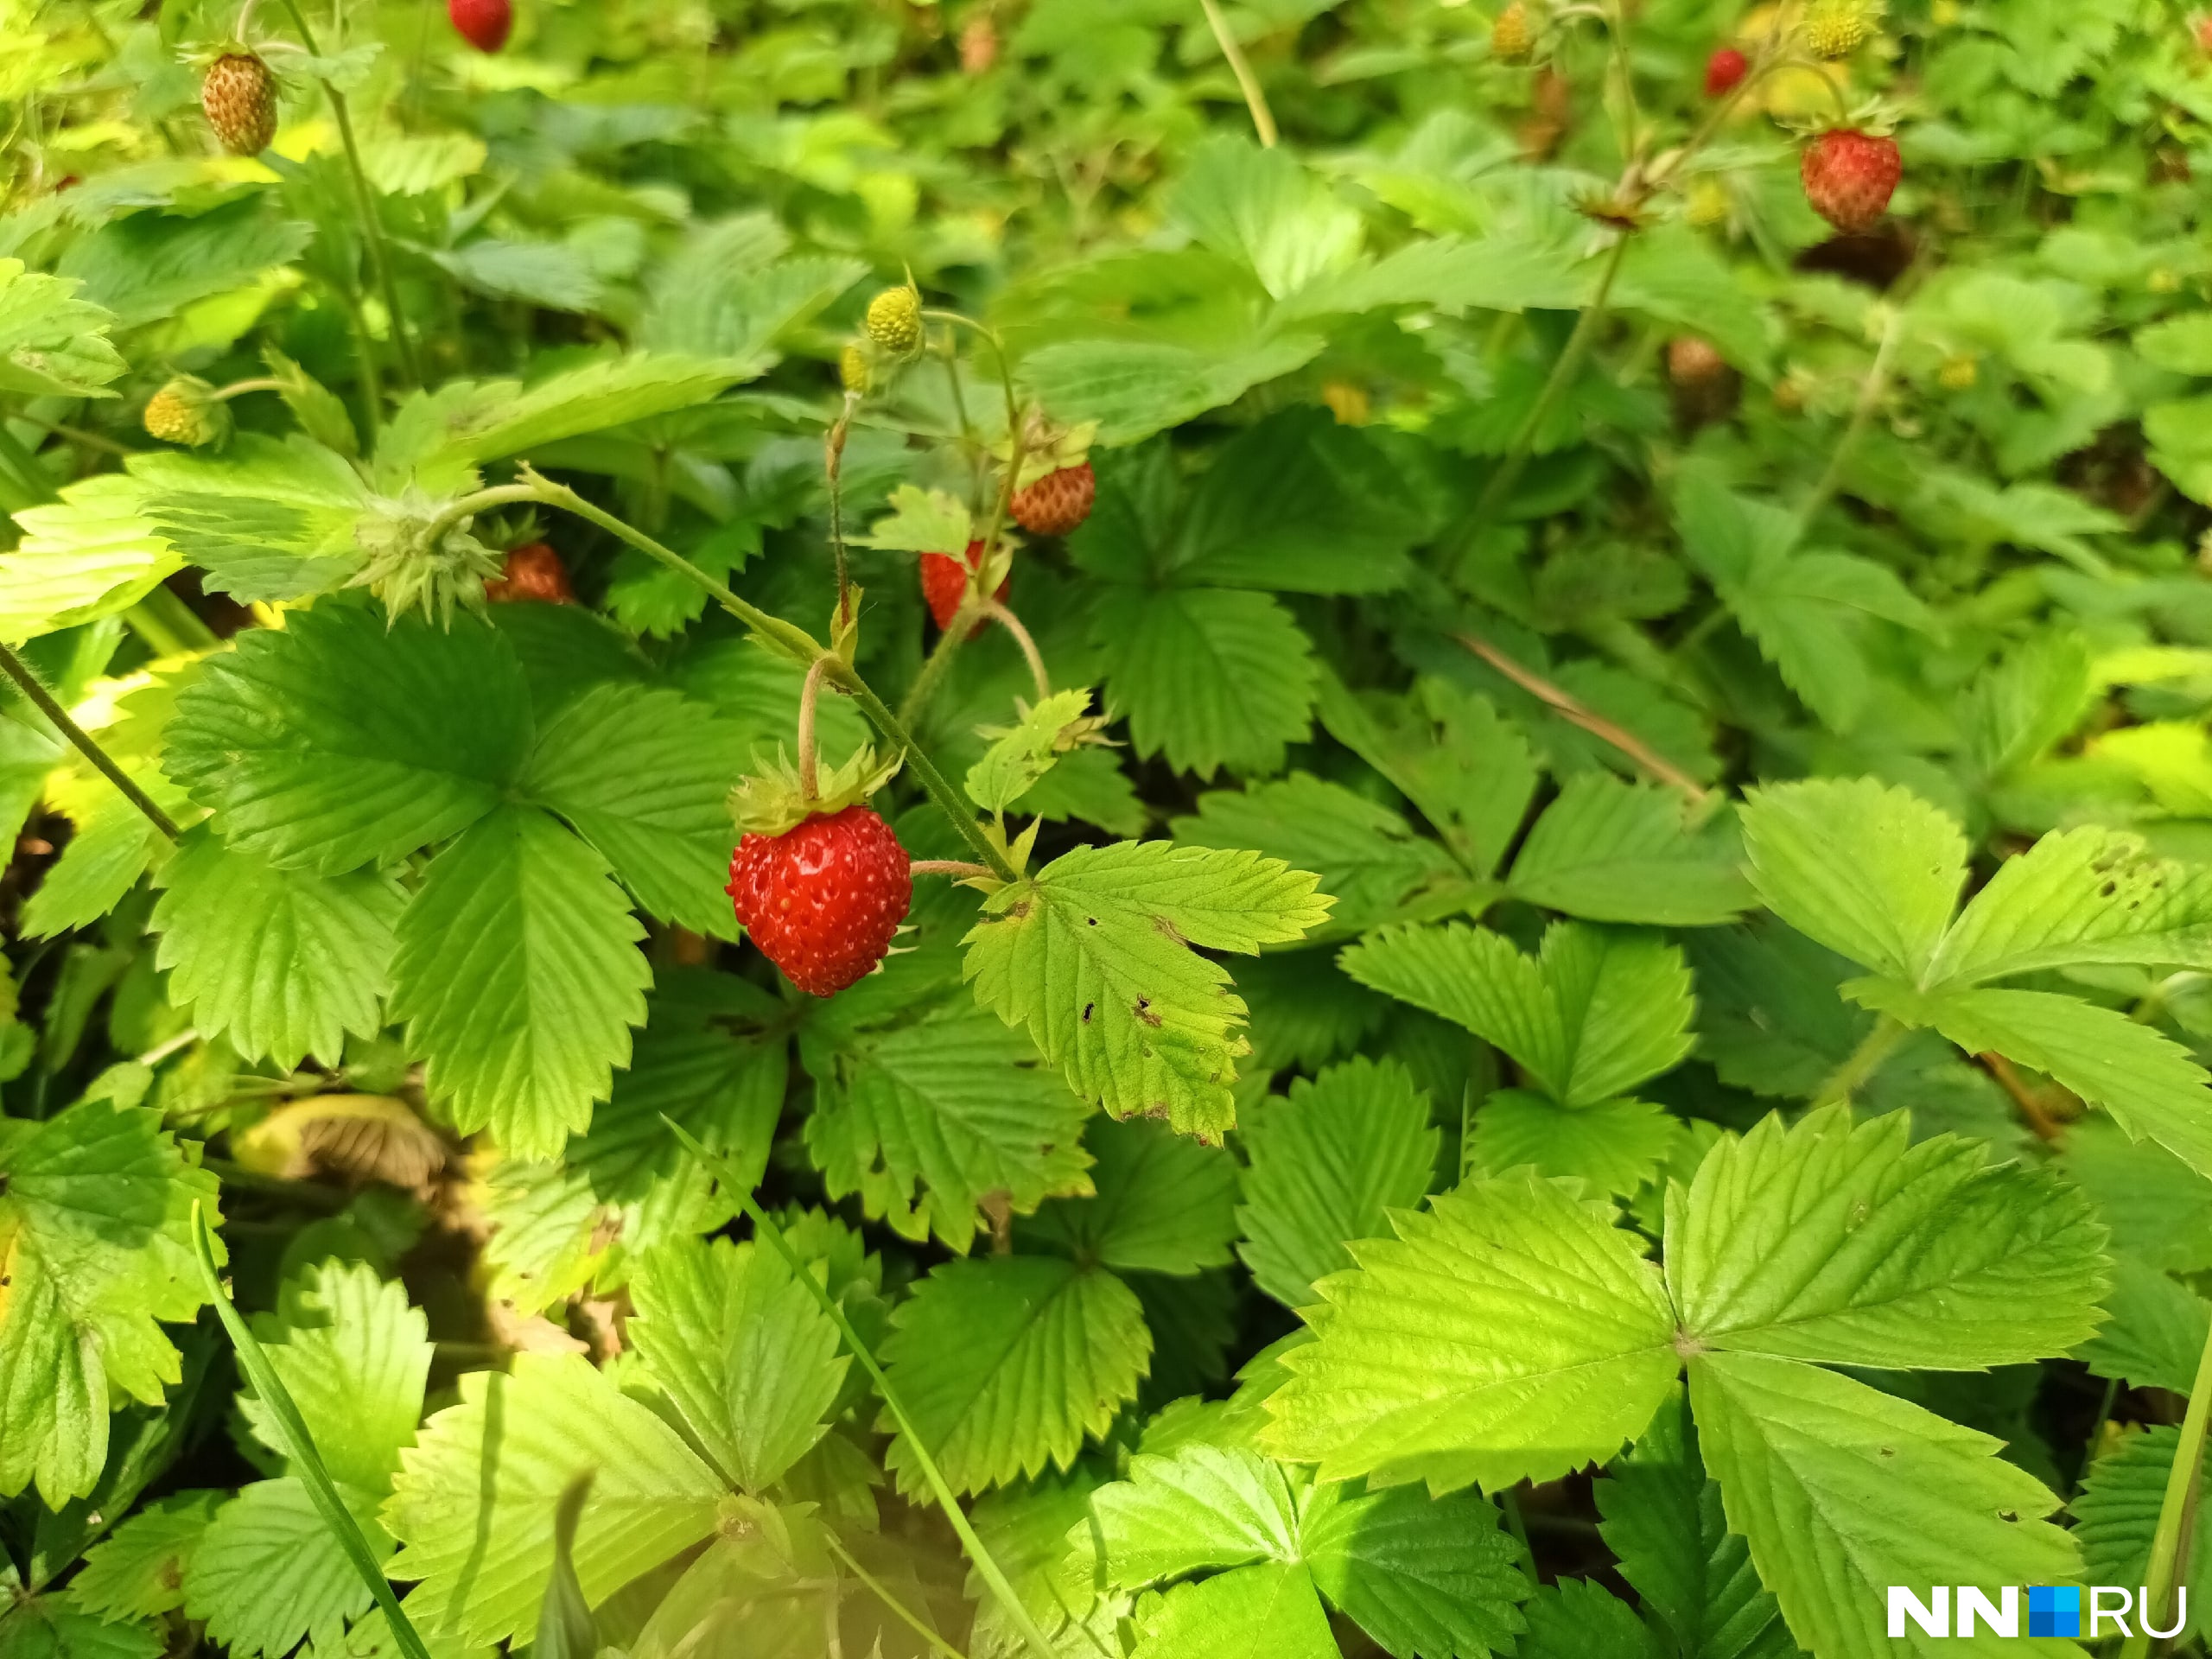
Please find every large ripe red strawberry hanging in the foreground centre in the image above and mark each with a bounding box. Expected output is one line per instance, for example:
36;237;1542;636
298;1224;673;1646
728;807;913;998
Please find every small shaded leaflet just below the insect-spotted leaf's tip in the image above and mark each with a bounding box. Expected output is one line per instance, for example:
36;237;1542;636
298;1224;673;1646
1022;1117;1236;1274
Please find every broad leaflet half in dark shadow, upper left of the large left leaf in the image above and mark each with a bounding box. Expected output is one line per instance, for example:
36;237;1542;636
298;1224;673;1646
163;601;531;876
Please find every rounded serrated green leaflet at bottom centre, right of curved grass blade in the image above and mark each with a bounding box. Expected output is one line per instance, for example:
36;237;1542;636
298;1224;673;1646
880;1256;1153;1491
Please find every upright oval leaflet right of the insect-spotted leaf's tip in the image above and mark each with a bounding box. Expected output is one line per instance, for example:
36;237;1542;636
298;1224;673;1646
1236;1055;1440;1307
